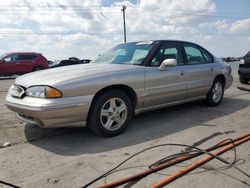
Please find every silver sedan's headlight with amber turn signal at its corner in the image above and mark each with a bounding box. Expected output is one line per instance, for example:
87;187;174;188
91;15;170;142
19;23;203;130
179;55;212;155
25;86;62;98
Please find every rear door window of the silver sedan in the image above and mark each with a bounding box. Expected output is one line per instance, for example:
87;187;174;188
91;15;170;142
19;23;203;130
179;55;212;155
184;44;206;64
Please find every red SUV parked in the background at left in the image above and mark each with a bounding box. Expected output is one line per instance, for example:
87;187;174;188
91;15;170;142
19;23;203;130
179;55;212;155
0;52;49;76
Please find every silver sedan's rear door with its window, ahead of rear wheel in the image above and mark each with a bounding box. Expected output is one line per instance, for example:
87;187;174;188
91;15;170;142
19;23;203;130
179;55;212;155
183;43;214;98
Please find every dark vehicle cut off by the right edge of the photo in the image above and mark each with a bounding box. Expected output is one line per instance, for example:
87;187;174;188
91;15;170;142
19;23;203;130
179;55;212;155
238;51;250;84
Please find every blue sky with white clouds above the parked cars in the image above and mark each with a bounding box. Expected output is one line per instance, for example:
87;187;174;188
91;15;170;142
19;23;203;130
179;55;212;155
0;0;250;60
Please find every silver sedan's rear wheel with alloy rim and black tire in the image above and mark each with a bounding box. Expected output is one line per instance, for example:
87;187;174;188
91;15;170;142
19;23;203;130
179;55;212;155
205;78;224;107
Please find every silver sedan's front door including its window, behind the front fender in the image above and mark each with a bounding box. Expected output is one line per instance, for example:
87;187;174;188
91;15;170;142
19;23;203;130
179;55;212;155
144;42;188;108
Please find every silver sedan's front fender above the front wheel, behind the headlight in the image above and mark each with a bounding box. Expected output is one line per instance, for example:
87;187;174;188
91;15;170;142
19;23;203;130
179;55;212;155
55;65;145;107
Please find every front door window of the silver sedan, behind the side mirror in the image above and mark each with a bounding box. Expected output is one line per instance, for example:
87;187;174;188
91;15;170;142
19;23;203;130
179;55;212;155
150;42;184;66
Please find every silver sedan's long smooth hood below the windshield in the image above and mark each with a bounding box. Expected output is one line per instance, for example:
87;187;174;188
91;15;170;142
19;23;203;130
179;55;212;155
15;63;142;88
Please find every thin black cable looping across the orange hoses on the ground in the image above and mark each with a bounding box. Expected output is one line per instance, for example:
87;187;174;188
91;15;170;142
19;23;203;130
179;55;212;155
82;139;249;188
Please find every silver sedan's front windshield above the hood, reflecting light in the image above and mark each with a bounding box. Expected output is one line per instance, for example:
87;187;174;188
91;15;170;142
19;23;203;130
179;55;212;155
91;42;154;65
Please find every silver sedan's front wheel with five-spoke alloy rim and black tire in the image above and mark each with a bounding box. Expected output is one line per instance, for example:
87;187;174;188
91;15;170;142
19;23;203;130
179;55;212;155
87;90;133;137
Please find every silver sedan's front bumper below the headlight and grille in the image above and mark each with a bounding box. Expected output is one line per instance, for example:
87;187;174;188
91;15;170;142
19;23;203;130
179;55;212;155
6;94;93;128
